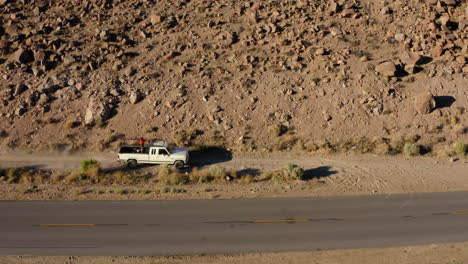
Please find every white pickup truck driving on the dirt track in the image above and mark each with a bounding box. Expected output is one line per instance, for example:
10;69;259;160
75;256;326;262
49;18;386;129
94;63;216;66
119;141;189;169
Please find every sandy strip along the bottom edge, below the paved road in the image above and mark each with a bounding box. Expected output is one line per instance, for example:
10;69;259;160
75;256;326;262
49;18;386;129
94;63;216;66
0;243;468;264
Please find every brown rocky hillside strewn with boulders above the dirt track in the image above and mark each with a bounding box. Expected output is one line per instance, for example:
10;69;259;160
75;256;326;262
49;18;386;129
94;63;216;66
0;0;468;153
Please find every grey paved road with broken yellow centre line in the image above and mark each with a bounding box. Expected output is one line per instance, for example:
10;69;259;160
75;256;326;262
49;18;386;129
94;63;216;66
0;193;468;255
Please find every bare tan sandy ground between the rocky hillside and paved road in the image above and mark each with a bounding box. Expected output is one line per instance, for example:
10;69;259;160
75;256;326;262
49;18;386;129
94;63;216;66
0;154;468;200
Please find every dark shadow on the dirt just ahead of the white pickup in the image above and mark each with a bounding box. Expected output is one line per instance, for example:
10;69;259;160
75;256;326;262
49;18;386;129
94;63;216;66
189;146;232;167
